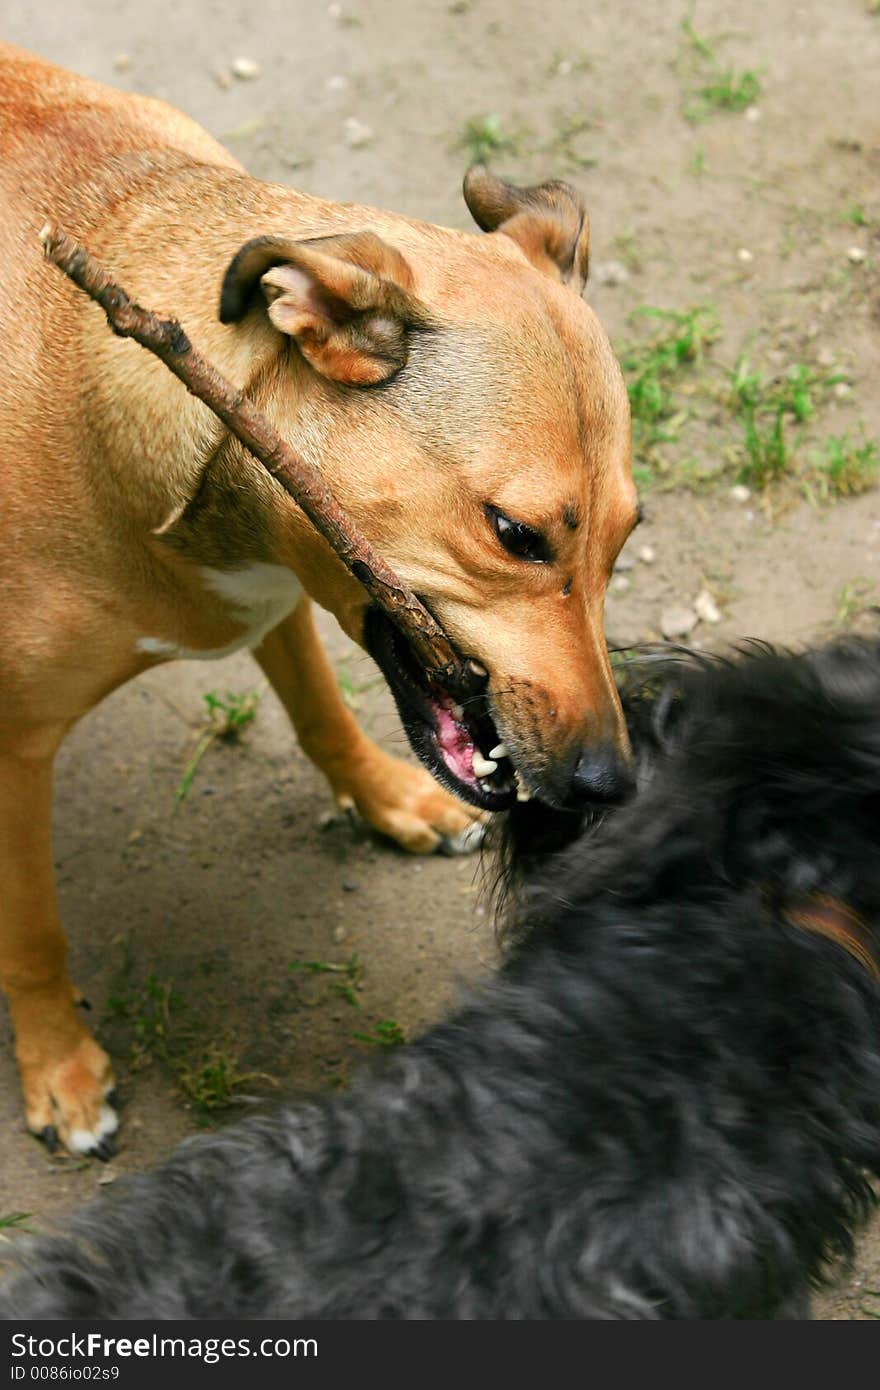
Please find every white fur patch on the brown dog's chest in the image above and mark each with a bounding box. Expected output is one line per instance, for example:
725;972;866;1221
136;560;303;660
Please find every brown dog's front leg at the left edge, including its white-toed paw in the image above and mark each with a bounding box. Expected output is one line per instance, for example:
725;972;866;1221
0;731;117;1156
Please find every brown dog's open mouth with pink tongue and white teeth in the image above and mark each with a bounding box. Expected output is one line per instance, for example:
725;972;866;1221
364;607;519;810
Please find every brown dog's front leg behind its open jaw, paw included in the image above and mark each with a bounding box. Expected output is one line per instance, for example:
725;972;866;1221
254;598;481;855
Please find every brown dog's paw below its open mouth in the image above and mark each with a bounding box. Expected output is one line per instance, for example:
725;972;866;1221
336;749;487;855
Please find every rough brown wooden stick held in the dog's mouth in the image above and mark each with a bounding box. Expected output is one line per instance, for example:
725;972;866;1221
40;222;485;699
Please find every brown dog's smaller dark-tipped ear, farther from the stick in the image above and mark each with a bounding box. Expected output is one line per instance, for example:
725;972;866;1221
463;164;589;295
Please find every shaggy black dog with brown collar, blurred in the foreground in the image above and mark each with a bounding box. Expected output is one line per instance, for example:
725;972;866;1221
0;642;880;1319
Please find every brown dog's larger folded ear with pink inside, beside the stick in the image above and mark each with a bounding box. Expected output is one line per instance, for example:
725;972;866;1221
220;232;430;386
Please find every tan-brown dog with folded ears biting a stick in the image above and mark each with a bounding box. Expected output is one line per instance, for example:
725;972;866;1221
0;47;637;1154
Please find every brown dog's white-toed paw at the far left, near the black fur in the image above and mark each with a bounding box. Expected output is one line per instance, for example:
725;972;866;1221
21;1033;120;1159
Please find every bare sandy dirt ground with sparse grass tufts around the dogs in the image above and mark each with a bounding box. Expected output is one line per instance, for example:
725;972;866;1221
0;0;880;1319
